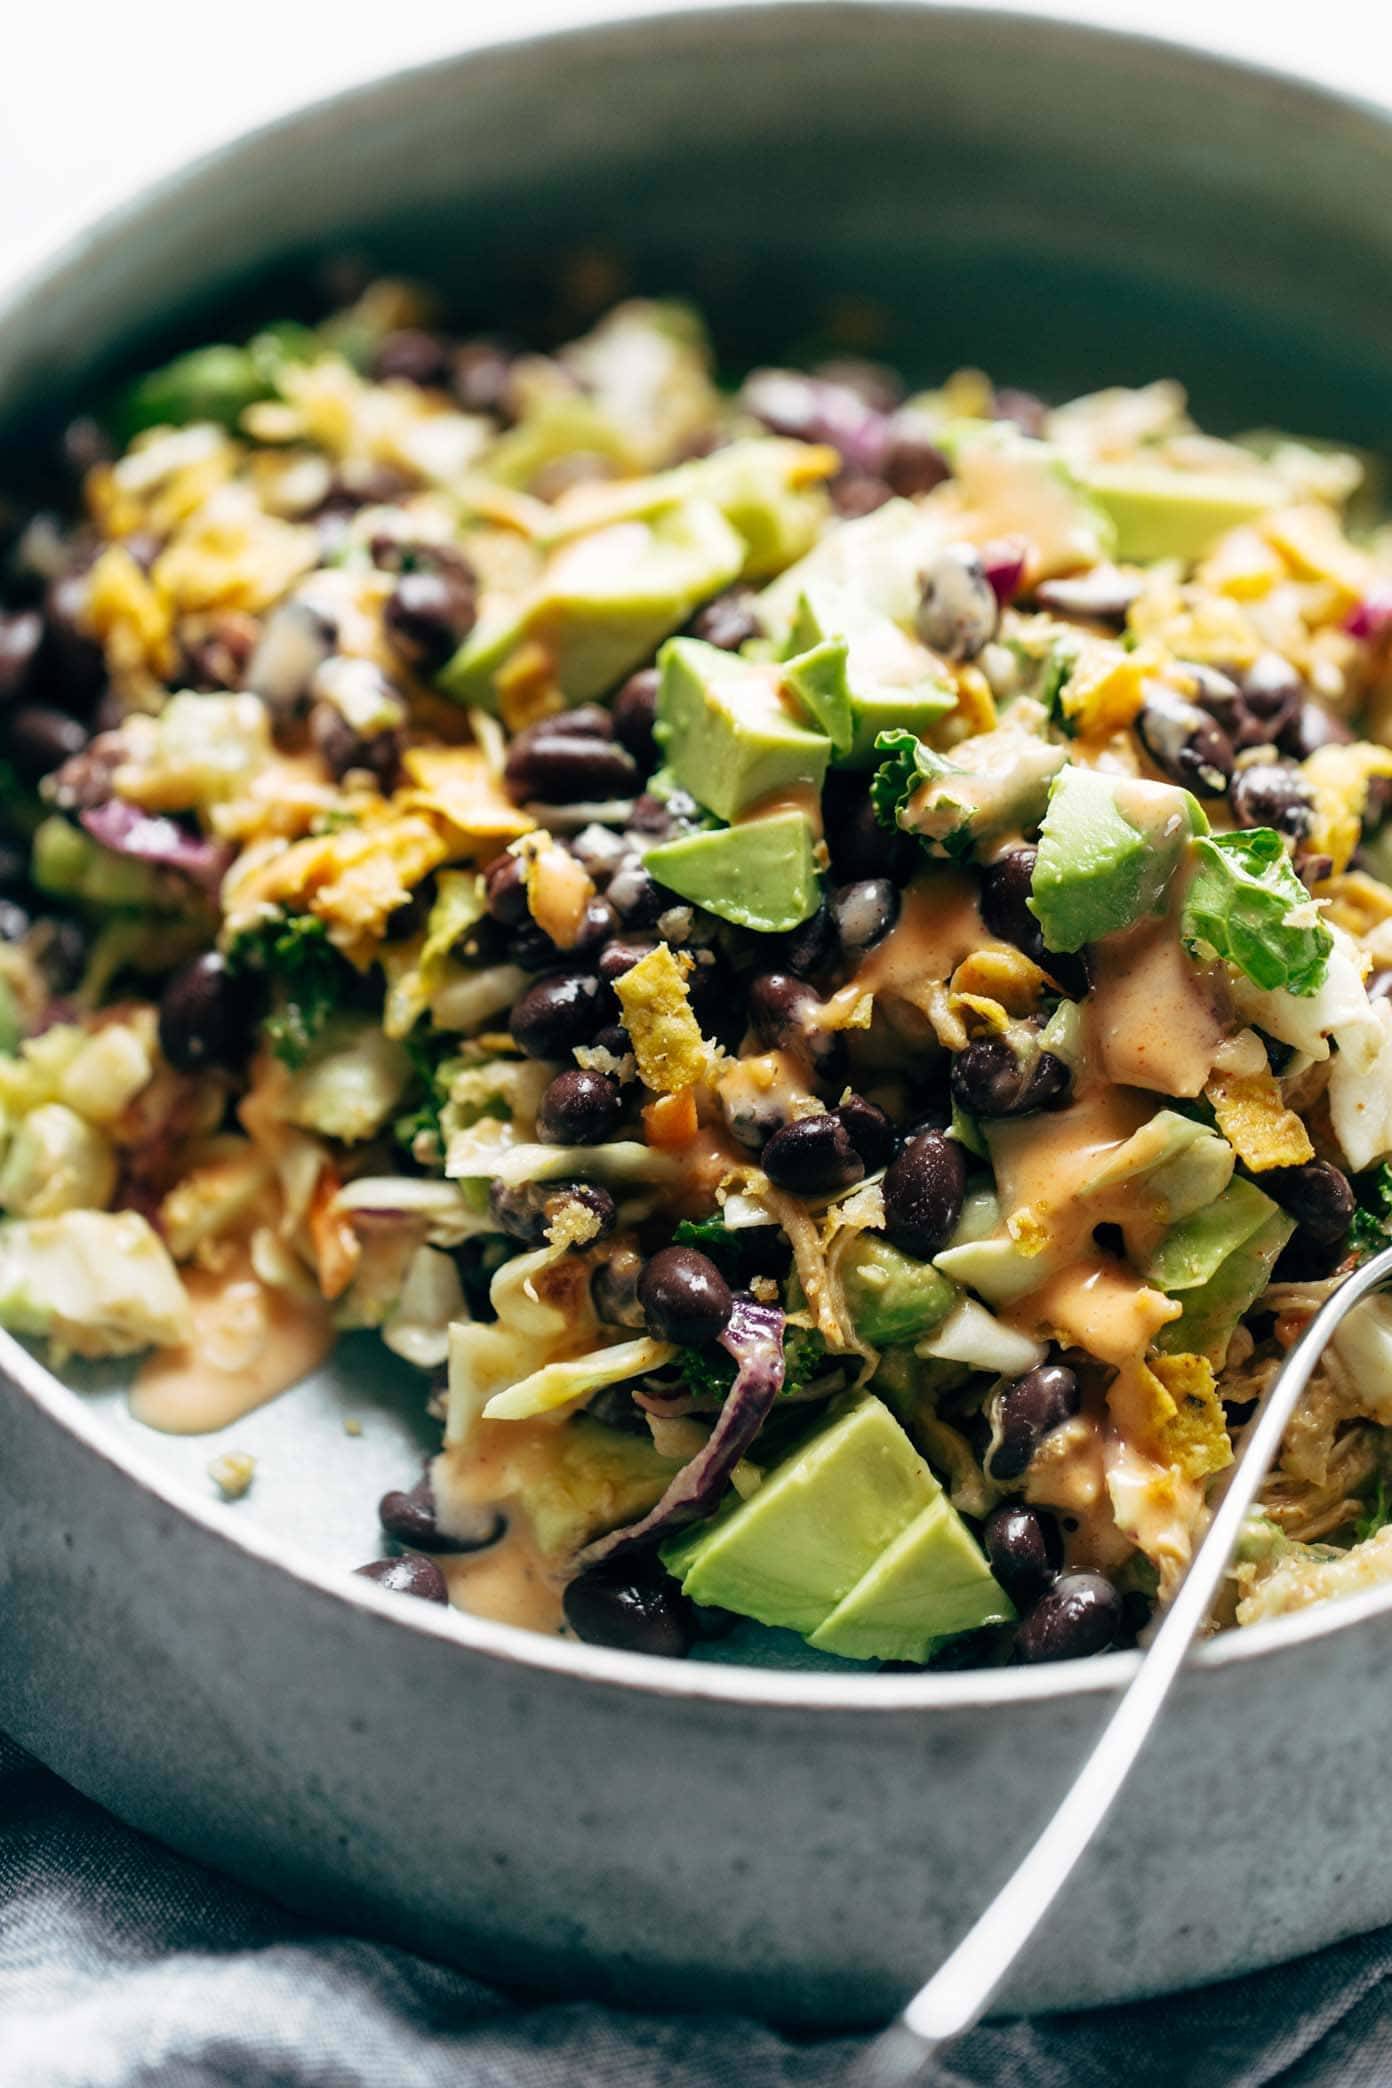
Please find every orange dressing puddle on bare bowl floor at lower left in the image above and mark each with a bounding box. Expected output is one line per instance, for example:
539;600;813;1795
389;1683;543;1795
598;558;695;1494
131;1255;334;1434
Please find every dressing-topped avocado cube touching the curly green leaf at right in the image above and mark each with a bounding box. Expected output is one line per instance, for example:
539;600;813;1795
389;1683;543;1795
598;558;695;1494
1029;762;1208;950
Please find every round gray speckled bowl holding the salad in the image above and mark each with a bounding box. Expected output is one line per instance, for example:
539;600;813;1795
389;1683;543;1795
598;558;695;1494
0;6;1392;2023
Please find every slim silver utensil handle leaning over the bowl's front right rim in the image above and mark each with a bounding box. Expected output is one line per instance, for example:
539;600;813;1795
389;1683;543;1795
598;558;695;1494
854;1247;1392;2088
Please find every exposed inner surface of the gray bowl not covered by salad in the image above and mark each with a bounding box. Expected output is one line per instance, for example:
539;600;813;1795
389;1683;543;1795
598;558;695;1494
0;4;1392;1687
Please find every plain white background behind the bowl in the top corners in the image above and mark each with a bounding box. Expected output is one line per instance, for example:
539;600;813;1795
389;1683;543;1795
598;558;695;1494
0;0;1392;267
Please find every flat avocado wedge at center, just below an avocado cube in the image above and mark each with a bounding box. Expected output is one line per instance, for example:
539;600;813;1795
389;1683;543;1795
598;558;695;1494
643;810;822;935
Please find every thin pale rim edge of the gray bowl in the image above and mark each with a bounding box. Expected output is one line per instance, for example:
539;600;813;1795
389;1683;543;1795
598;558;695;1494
0;0;1392;1716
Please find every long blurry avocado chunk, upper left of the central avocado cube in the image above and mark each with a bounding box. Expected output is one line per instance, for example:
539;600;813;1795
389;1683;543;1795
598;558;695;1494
438;501;745;710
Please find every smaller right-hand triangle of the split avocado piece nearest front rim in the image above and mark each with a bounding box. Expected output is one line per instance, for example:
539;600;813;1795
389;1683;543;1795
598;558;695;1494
810;1493;1014;1660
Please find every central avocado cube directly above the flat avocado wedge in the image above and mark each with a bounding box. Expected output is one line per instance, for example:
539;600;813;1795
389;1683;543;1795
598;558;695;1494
657;639;831;818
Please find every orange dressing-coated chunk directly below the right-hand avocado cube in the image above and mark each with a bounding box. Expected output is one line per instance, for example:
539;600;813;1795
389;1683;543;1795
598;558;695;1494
1083;917;1227;1096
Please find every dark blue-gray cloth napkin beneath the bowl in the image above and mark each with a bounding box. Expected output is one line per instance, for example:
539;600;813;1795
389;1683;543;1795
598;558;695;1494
0;1739;1392;2088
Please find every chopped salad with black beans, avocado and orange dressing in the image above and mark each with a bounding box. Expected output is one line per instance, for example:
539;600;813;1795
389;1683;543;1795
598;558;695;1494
0;282;1392;1666
